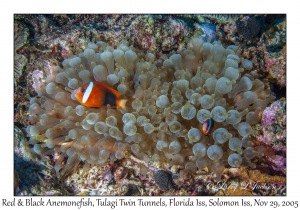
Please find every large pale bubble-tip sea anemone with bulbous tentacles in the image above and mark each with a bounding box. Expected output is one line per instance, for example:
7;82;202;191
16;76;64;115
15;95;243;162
27;38;274;178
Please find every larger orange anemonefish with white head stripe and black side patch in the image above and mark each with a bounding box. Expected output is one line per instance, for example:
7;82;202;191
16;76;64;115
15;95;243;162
74;82;127;109
